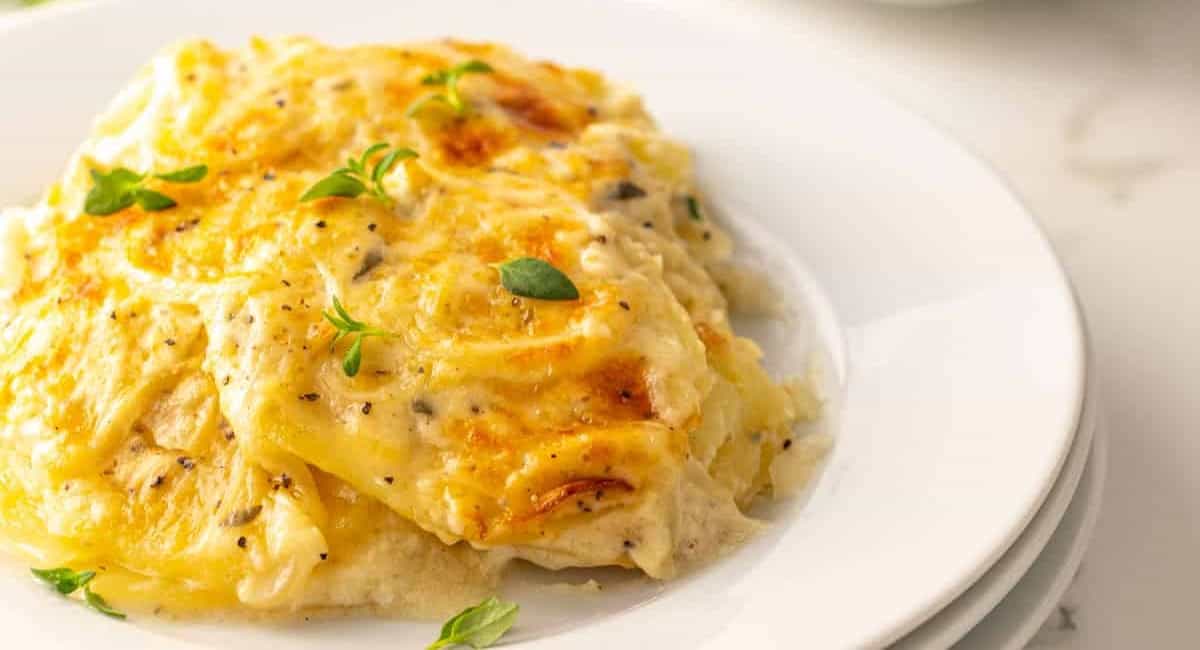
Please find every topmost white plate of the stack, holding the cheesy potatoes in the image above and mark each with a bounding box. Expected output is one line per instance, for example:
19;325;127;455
0;0;1084;650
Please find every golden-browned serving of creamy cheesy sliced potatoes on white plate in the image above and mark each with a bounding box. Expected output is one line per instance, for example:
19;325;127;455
0;38;816;615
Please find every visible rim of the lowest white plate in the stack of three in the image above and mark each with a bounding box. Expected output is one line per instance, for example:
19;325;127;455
954;422;1109;650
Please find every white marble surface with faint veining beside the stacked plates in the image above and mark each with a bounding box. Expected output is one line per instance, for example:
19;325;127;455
0;0;1200;650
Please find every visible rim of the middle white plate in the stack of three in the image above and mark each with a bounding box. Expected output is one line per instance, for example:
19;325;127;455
890;366;1100;650
